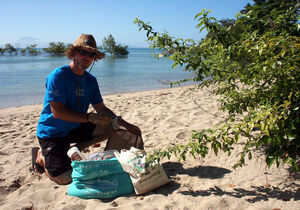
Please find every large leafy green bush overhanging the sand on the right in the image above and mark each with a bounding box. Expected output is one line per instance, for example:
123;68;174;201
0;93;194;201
135;0;300;170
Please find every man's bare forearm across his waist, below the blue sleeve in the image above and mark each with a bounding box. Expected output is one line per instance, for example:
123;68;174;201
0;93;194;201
50;101;88;122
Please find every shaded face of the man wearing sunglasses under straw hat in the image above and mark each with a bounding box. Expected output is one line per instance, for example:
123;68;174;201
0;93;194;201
74;48;96;70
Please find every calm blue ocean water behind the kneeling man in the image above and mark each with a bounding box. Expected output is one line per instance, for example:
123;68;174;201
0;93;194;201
0;48;189;108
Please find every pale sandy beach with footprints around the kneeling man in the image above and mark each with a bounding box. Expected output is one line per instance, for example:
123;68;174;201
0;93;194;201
0;87;300;210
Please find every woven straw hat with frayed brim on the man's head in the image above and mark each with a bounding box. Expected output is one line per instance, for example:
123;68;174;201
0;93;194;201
65;34;105;61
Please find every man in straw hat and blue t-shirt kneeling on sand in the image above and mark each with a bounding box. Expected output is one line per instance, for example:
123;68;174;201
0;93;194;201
32;34;143;184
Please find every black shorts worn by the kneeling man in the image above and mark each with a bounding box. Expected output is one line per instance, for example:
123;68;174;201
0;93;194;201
38;123;96;177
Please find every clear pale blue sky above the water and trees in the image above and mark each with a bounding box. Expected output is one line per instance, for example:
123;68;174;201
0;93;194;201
0;0;253;47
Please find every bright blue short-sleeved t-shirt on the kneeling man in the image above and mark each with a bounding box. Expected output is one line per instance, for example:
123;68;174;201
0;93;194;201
37;65;103;139
